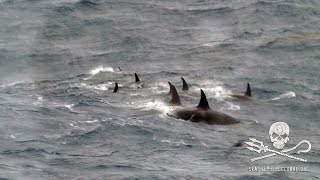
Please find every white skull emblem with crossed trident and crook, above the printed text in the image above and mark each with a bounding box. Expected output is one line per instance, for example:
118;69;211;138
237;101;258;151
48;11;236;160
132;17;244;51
245;122;311;162
